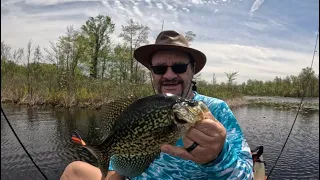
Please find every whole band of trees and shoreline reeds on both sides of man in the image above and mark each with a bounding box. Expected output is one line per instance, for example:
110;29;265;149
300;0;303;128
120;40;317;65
1;15;319;107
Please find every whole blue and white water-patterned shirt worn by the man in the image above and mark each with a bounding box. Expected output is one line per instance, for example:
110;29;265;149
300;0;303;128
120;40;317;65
109;92;253;180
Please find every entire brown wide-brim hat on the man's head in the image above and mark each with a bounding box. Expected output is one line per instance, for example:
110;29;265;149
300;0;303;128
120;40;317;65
133;30;207;74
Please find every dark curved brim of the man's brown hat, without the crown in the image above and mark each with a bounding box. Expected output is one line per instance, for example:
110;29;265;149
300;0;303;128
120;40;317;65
133;44;207;74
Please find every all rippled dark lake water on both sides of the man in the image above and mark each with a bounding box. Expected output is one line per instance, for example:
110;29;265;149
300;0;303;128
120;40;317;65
1;102;319;180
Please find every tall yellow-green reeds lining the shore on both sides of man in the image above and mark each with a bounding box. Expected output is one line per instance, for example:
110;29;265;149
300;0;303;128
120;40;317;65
1;75;248;108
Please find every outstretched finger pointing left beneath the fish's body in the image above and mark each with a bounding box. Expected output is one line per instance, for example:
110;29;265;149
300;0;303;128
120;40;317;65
161;144;195;160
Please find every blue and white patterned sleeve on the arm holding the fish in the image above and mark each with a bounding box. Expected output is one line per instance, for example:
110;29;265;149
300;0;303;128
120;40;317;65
196;100;253;179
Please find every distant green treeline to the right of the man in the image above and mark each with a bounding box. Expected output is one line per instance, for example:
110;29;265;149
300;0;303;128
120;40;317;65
198;67;319;97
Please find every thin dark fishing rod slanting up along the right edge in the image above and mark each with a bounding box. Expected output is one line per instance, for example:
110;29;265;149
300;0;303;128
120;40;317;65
267;27;319;179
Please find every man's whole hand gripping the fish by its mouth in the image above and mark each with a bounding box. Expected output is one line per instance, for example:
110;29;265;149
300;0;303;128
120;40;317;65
161;112;226;164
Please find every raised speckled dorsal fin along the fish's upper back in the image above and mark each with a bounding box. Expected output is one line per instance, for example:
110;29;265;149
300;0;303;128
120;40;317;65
100;95;139;141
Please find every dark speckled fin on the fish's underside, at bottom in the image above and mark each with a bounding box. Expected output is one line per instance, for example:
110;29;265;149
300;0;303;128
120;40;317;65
111;152;160;178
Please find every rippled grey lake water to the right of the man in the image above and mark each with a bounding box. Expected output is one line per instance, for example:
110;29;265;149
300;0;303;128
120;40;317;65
234;107;319;179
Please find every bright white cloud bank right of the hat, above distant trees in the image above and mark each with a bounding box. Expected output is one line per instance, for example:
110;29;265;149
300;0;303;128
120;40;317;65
193;42;319;82
